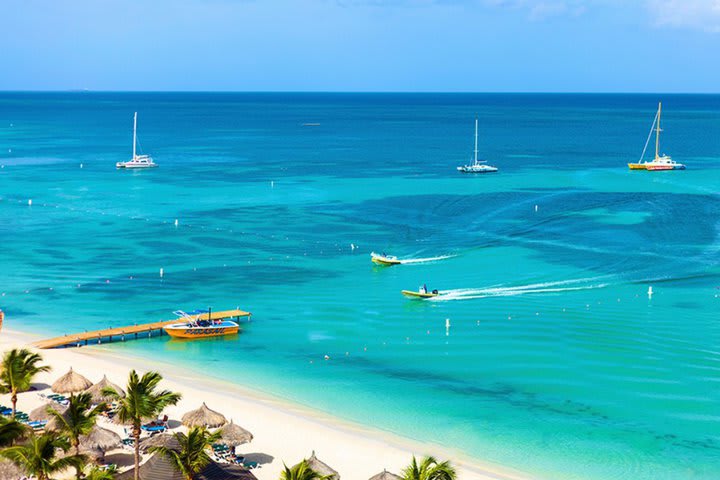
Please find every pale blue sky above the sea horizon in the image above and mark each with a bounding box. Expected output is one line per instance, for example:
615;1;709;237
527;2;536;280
0;0;720;93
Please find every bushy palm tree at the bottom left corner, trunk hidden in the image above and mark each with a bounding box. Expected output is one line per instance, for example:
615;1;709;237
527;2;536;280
0;433;85;480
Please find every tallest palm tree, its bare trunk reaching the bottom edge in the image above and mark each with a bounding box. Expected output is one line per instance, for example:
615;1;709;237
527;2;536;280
103;370;181;480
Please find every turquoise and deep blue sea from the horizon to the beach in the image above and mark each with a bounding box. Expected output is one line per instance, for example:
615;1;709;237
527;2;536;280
0;93;720;479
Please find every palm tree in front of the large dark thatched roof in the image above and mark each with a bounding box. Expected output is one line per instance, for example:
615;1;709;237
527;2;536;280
148;427;221;480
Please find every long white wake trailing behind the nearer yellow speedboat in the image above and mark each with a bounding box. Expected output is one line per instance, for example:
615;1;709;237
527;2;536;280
431;278;608;302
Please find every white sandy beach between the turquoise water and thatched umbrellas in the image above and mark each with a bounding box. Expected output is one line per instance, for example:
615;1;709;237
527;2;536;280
0;330;529;480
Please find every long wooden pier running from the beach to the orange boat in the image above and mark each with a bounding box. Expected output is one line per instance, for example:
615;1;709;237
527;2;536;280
33;310;250;348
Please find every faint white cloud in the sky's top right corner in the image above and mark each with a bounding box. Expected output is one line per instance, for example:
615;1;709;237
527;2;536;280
647;0;720;32
